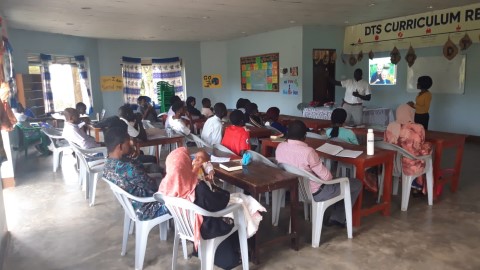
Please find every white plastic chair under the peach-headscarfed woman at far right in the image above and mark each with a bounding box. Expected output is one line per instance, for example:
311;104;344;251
375;141;433;211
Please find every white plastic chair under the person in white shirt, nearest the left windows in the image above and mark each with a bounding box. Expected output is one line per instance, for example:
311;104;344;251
69;142;107;206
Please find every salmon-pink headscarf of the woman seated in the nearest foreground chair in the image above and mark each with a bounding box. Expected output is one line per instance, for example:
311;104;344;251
158;147;203;248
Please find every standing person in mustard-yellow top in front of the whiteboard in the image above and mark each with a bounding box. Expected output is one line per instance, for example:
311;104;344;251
415;76;433;130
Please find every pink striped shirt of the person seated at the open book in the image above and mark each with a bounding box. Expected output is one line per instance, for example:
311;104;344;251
275;140;332;193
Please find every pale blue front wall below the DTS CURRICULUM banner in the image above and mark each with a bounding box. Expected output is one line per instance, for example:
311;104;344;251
336;43;480;136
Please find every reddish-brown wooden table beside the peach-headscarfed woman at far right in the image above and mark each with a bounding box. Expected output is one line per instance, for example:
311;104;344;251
352;128;467;200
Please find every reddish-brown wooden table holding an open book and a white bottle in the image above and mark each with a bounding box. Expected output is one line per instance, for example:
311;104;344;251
261;138;395;227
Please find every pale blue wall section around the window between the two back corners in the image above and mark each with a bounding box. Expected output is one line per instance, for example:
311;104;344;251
98;39;203;116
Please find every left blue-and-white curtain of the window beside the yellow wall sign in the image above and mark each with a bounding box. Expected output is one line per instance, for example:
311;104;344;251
122;57;142;105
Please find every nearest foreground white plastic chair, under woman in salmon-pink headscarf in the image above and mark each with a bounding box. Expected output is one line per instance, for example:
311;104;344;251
154;193;249;270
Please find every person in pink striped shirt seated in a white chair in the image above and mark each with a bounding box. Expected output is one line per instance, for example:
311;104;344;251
275;120;362;227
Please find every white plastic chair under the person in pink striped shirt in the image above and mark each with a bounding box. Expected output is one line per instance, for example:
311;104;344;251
278;163;352;248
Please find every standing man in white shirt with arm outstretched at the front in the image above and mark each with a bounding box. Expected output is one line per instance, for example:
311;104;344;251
330;68;372;126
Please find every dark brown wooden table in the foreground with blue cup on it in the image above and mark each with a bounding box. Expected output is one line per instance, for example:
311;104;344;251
214;162;298;263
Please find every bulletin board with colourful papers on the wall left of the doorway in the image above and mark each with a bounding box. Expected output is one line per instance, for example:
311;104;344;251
240;53;279;92
